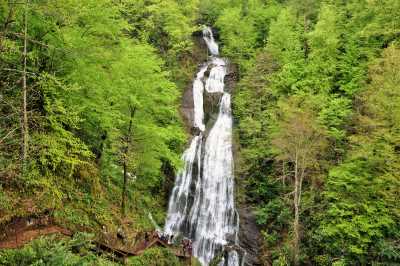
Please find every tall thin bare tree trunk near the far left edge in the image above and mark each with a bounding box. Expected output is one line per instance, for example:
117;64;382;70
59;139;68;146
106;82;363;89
21;0;29;173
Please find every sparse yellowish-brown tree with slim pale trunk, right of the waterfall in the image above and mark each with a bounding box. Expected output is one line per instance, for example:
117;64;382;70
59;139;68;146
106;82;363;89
272;98;326;265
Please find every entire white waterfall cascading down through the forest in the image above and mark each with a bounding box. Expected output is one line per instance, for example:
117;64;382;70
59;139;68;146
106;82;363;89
164;28;243;266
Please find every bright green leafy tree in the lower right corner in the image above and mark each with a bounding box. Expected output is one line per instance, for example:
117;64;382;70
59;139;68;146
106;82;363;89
320;162;396;261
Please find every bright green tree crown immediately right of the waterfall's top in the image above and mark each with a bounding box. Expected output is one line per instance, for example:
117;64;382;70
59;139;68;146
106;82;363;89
211;0;279;70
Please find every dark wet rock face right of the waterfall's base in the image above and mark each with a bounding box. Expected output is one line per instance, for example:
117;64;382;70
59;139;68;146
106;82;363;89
238;206;262;266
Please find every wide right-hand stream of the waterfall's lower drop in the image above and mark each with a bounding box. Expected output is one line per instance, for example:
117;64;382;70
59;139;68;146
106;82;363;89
194;93;238;265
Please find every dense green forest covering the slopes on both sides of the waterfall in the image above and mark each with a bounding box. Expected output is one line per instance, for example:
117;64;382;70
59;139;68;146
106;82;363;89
0;0;400;266
